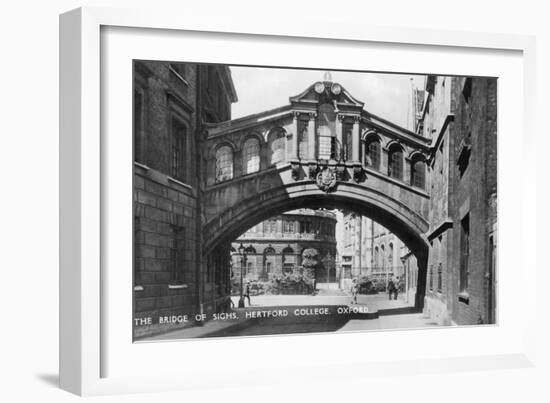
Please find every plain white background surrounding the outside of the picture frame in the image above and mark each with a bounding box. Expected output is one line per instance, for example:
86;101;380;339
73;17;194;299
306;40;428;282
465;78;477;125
0;0;550;403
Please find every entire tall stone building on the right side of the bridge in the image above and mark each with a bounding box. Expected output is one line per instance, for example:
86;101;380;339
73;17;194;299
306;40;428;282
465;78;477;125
418;76;497;324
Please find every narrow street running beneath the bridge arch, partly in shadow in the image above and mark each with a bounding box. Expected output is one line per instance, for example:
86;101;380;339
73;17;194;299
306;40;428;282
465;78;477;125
144;289;437;341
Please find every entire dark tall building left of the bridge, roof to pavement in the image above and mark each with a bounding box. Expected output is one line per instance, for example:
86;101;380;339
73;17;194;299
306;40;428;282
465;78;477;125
133;61;237;337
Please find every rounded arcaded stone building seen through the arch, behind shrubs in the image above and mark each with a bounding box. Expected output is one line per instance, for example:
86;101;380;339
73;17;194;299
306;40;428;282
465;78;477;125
232;209;336;283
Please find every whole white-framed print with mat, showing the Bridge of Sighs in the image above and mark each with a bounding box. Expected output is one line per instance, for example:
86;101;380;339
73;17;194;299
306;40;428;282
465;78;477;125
60;9;535;394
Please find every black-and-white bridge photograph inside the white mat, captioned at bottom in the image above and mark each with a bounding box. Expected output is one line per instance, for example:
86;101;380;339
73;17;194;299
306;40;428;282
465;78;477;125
131;60;498;342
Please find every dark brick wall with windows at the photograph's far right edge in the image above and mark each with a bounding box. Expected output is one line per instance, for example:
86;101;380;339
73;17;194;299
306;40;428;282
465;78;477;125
450;78;497;324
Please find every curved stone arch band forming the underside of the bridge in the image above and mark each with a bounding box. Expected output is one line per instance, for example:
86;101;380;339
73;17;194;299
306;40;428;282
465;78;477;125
203;183;429;309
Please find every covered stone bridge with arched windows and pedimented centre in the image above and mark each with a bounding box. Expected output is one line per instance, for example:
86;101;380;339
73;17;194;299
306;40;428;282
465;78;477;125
202;77;436;308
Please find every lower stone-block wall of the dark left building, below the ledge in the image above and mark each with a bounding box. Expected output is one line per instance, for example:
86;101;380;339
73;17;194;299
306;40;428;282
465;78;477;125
134;165;199;337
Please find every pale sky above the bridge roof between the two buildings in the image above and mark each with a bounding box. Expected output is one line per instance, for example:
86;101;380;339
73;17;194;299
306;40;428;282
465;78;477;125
230;66;425;127
